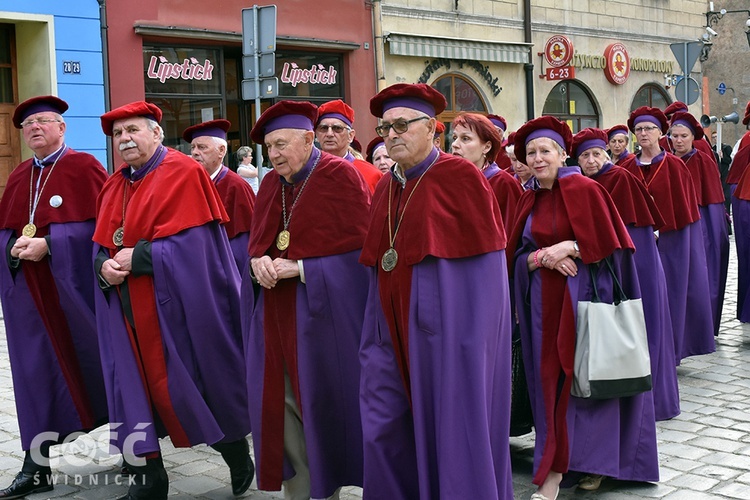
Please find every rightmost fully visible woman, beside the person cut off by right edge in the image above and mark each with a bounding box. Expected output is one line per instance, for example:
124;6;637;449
670;111;729;335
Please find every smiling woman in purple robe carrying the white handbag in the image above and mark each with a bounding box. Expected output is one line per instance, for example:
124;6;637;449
509;116;659;500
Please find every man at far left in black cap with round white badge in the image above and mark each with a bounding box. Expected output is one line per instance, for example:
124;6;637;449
0;96;107;498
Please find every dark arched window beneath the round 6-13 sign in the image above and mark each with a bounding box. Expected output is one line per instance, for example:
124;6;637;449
542;80;599;134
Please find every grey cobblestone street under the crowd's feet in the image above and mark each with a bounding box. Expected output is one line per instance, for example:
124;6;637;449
0;235;750;500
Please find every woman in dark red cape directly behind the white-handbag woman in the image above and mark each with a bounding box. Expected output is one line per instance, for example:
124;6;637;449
573;128;680;420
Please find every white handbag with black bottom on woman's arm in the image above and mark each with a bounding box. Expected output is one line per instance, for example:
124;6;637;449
571;259;651;399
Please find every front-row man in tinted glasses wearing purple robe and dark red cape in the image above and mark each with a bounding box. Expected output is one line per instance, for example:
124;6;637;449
360;84;513;499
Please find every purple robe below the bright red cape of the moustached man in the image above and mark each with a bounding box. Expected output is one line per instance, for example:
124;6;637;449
96;222;250;455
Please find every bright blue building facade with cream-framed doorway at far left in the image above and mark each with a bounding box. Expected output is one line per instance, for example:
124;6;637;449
0;0;107;193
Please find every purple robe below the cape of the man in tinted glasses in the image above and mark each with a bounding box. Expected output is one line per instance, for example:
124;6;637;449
360;254;513;500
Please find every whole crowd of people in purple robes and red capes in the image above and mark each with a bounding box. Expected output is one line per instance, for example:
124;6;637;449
0;84;750;500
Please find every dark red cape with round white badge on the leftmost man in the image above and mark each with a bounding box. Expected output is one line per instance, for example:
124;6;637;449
0;149;107;235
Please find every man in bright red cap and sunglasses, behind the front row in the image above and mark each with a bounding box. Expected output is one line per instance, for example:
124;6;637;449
315;99;383;192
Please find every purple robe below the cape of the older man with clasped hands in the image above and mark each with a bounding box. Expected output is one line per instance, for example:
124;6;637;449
242;250;367;498
